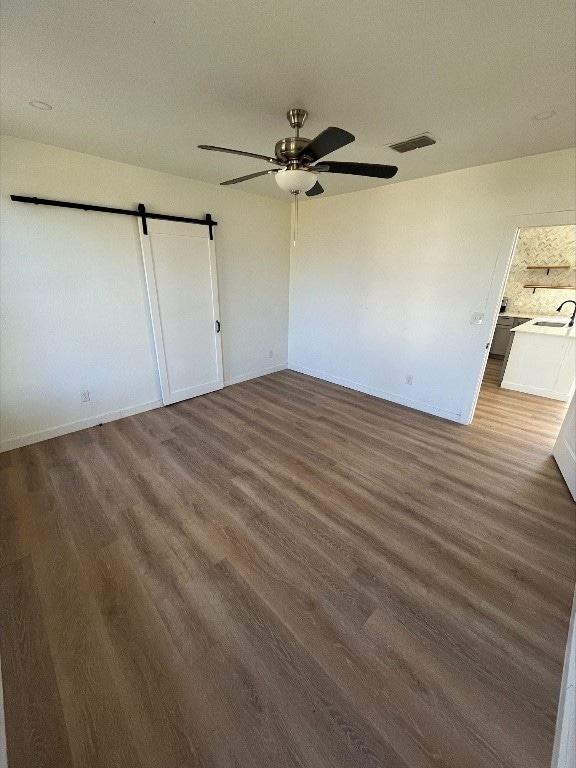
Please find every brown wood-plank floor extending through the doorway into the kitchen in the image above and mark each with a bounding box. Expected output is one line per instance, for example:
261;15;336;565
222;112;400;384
0;362;576;768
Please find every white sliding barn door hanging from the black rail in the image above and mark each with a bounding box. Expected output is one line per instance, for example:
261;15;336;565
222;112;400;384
139;219;223;405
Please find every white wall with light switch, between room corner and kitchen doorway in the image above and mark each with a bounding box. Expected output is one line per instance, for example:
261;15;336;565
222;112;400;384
288;150;575;421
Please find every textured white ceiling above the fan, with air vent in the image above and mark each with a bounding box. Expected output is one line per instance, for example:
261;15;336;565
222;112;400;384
1;0;576;197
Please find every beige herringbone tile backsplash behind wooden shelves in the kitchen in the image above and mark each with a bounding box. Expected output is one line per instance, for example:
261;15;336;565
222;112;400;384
504;226;576;315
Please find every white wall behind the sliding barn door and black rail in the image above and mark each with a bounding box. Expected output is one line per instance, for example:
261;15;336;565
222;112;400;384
0;137;290;449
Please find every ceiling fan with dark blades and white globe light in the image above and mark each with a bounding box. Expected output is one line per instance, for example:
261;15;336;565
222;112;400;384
199;109;398;197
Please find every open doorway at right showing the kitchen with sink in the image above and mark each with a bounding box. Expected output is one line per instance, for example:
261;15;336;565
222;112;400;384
474;224;576;496
